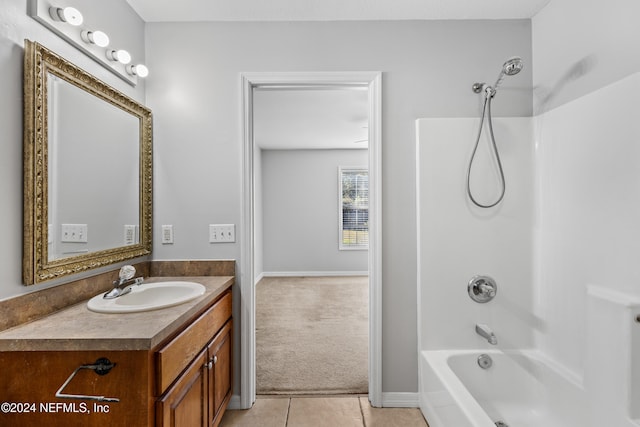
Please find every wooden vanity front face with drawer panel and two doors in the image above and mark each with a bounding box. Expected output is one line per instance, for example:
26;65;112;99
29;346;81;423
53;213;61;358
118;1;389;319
156;293;233;427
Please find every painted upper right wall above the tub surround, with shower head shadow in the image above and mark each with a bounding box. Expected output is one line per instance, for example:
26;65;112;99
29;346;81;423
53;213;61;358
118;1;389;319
532;0;640;113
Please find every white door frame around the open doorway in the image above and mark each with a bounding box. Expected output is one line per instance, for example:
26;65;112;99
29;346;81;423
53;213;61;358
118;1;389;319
240;71;382;409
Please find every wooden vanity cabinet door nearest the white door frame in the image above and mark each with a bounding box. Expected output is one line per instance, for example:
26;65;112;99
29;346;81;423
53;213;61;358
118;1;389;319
208;320;233;426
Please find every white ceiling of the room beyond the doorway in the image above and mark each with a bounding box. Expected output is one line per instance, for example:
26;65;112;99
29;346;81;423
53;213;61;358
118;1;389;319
253;88;369;150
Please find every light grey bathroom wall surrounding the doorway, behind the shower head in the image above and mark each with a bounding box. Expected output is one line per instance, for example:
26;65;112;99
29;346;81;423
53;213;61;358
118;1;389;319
147;20;532;392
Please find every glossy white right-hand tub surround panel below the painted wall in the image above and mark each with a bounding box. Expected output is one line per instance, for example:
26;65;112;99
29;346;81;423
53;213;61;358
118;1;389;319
531;73;640;381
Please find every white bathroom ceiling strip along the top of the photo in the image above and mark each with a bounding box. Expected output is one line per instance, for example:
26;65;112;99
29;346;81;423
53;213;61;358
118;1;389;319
127;0;550;22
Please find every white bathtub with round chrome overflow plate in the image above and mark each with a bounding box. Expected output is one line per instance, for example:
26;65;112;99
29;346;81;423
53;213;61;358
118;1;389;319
420;350;591;427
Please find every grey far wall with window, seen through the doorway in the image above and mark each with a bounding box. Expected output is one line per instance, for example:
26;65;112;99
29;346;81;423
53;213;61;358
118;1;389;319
261;150;368;274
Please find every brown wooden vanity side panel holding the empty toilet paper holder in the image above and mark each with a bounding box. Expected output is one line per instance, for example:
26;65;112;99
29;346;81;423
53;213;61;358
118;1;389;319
0;350;155;427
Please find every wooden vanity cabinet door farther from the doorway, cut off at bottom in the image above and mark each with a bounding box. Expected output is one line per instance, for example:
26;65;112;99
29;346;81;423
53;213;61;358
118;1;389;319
156;350;208;427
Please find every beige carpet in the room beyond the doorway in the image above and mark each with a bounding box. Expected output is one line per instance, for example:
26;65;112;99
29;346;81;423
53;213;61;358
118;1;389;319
256;276;369;394
